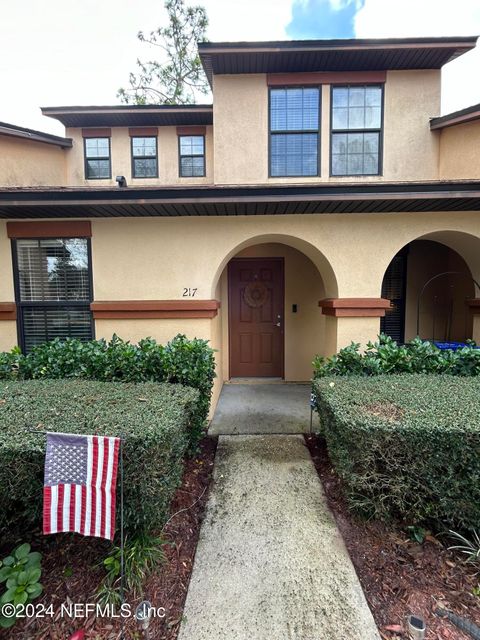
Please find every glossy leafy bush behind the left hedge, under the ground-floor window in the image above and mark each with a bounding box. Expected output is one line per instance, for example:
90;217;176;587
0;335;215;450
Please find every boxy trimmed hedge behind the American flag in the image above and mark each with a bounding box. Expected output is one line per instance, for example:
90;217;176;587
0;380;199;537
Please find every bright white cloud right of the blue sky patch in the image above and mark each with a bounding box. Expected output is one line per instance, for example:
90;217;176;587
355;0;480;113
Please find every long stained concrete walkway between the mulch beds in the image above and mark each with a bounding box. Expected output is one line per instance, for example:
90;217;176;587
179;436;380;640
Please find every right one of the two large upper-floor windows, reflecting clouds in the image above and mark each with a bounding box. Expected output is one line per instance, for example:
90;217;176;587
331;85;383;176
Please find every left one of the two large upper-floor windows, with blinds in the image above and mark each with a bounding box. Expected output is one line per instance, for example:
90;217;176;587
270;87;320;177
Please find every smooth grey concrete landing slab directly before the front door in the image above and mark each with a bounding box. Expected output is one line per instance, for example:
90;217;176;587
208;383;311;435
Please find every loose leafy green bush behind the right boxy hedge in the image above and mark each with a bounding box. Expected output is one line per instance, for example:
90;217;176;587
313;334;480;378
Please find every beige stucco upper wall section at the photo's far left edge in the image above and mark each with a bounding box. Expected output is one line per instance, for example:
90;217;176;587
0;135;68;187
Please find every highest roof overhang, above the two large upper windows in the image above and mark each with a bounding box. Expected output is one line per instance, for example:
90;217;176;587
198;36;477;84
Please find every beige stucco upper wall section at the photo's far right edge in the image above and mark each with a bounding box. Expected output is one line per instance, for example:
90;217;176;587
440;120;480;180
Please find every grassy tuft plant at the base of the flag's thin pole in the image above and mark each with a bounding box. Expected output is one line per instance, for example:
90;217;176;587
97;534;166;604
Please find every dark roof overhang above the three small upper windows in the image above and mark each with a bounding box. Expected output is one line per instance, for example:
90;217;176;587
42;104;213;127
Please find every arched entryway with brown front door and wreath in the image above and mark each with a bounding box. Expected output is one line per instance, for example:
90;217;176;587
215;236;336;381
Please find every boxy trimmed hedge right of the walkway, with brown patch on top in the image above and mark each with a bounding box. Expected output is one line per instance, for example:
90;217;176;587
314;374;480;529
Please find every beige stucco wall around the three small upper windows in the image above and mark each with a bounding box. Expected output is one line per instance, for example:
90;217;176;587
66;126;213;187
